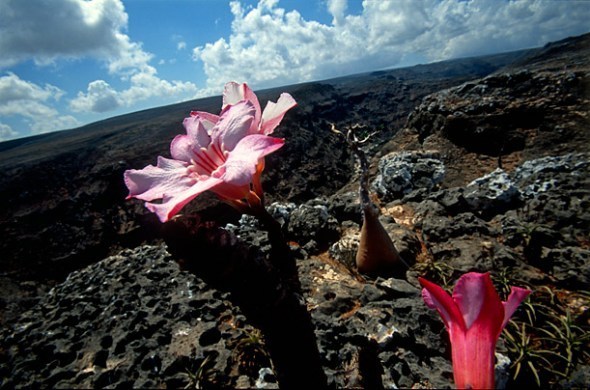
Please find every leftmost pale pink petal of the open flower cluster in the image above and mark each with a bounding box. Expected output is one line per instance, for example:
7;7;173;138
124;156;194;200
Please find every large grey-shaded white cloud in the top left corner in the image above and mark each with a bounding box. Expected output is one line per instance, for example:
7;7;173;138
0;0;130;66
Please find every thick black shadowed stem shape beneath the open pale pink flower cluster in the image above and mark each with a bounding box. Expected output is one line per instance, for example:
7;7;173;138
163;217;327;388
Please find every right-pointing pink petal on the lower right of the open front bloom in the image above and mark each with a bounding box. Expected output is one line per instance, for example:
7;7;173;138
220;134;285;186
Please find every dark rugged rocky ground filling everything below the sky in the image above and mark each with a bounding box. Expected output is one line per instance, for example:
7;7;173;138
0;36;590;388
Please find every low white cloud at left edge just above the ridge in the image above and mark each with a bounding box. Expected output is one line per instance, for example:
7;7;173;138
0;72;80;140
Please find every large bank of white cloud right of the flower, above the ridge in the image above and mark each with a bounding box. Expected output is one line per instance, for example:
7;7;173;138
193;0;590;89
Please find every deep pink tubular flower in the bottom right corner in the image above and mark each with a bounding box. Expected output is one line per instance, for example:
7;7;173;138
418;272;531;389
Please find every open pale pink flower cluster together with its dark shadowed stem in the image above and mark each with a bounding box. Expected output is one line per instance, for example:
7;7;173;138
124;82;326;388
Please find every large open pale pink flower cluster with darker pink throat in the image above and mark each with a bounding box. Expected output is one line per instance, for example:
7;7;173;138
124;82;297;222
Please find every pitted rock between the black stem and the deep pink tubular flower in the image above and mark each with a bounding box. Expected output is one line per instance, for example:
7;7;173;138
299;257;452;388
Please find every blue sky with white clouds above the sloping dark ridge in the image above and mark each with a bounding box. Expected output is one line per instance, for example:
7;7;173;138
0;0;590;141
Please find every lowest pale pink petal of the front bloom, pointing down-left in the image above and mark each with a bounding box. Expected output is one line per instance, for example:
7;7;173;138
145;177;223;222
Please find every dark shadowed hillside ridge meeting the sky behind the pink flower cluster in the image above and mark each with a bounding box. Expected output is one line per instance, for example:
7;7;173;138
0;31;589;286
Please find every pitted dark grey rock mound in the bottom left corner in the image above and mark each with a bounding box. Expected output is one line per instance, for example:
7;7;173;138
0;246;269;387
